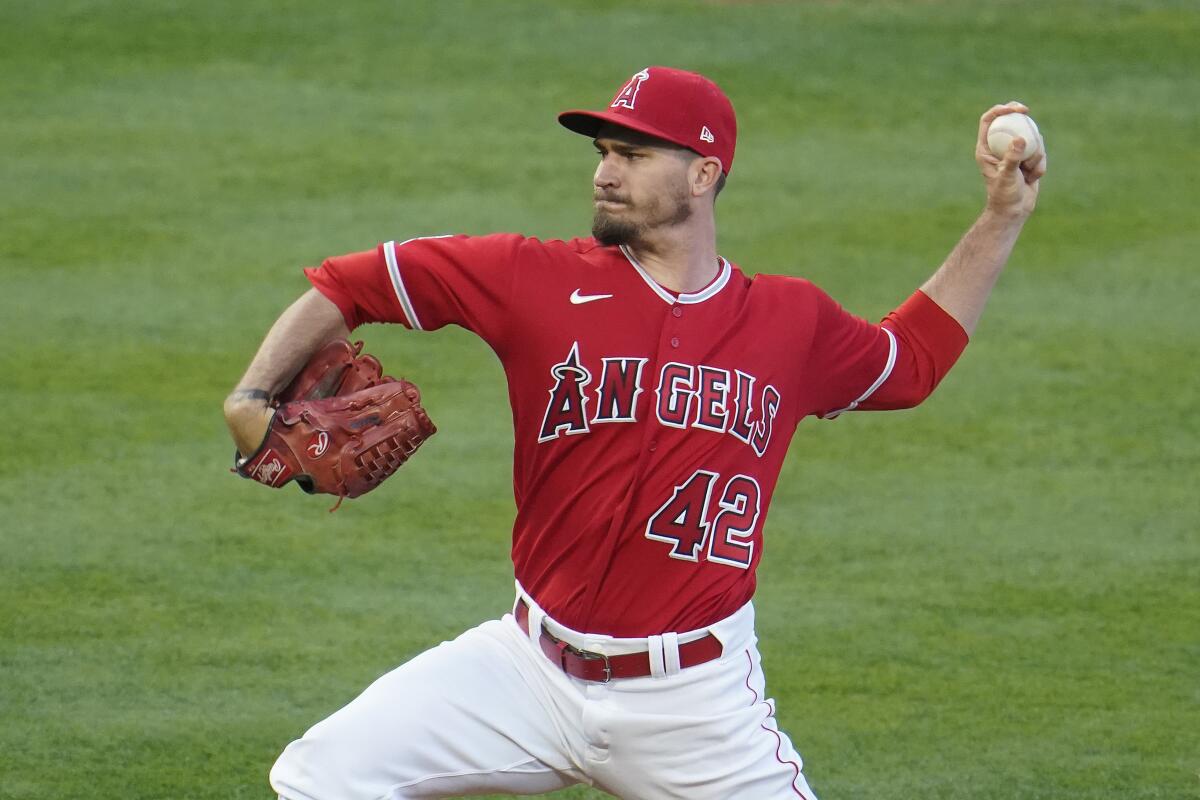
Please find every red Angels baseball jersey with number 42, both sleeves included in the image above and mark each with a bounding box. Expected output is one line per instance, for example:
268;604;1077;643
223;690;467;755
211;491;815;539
306;234;966;637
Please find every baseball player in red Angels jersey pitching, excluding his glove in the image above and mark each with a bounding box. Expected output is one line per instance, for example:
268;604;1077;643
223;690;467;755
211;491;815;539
226;67;1045;800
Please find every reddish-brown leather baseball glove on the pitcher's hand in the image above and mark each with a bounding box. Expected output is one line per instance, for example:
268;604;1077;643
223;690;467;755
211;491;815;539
234;339;437;511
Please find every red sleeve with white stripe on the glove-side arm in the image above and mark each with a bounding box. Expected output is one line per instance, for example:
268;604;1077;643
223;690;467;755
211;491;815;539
305;234;524;344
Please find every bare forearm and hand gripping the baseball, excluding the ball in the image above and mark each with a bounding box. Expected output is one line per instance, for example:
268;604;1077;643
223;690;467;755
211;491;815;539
920;102;1046;336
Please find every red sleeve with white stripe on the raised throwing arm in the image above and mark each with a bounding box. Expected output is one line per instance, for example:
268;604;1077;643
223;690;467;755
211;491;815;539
806;291;967;420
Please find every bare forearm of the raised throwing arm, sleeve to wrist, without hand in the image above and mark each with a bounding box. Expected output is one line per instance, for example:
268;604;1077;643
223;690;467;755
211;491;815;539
920;209;1026;336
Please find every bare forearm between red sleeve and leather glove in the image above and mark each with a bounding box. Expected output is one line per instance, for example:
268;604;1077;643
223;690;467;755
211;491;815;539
224;289;349;456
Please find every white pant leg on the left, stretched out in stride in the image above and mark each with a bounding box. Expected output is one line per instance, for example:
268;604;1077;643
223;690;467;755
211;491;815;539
271;620;584;800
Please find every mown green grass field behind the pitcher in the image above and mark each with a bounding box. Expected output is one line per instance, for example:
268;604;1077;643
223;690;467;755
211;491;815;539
0;0;1200;800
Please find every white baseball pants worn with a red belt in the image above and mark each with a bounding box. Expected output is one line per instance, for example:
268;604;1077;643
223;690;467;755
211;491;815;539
271;587;815;800
